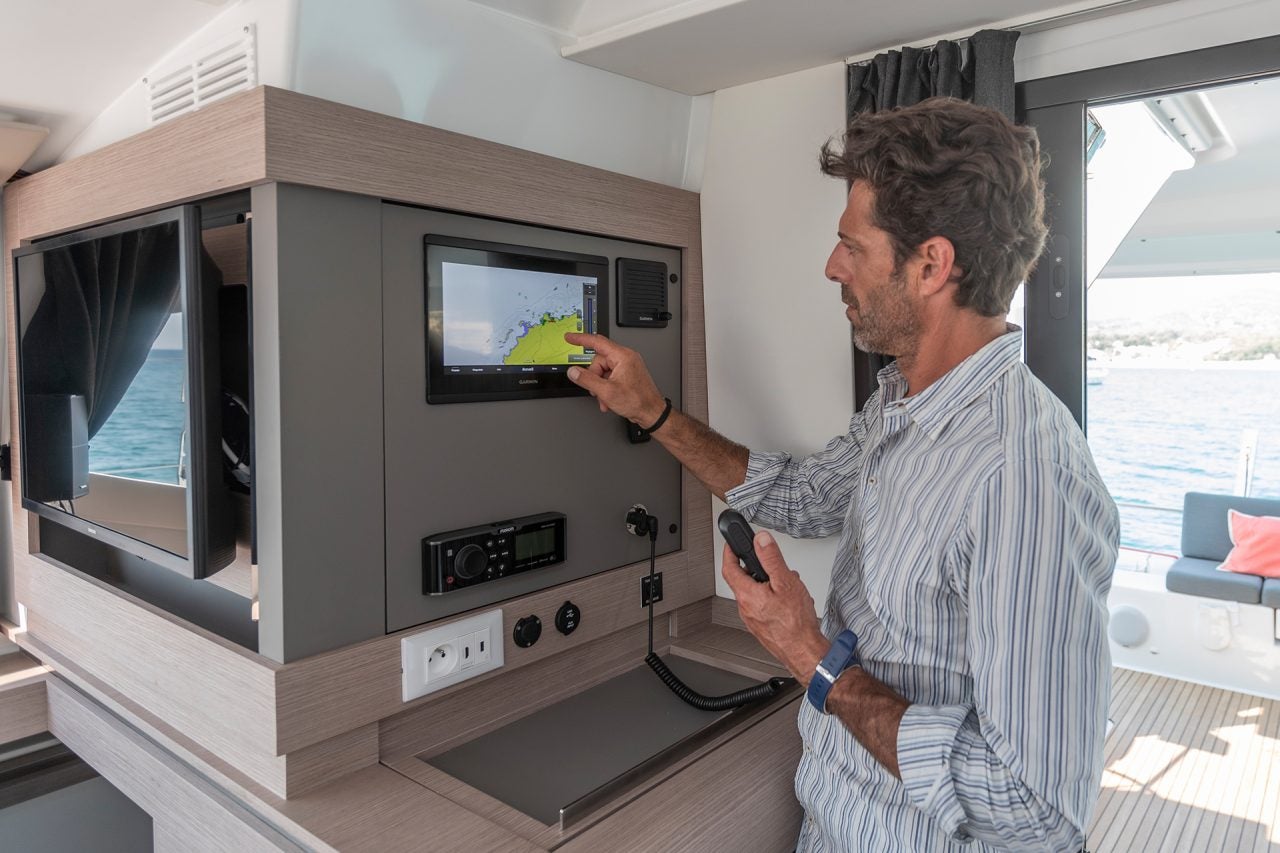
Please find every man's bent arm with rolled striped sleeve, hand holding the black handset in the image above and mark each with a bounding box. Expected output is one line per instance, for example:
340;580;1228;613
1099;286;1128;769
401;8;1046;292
722;460;1117;850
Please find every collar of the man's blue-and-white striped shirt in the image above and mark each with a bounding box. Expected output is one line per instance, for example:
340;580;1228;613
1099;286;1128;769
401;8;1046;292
877;325;1023;441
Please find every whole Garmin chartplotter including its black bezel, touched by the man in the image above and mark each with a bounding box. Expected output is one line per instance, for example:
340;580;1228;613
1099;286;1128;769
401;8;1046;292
425;236;608;402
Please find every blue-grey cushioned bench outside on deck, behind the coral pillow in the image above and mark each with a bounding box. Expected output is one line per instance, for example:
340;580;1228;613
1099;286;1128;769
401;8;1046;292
1165;492;1280;608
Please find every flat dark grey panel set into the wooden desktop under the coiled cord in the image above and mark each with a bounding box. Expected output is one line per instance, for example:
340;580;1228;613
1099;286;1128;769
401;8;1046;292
424;656;755;825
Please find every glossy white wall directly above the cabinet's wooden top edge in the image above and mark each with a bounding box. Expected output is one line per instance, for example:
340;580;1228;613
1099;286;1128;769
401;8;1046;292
296;0;709;188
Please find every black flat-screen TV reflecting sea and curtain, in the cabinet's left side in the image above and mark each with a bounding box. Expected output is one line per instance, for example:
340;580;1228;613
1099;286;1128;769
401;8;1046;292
14;205;236;578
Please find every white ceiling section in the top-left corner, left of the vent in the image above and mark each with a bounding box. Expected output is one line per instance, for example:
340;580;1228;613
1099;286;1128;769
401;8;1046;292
0;0;221;170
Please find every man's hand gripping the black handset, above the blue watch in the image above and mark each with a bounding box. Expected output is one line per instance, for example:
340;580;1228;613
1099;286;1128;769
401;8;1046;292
721;530;831;685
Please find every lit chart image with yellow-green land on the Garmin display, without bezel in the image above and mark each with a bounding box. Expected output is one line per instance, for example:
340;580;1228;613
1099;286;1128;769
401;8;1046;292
440;261;599;373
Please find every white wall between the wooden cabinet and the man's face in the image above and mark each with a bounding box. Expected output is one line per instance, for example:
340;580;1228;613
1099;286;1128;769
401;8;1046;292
703;63;852;608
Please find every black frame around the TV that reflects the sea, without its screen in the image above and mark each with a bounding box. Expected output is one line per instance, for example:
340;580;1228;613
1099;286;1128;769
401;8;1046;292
13;205;234;579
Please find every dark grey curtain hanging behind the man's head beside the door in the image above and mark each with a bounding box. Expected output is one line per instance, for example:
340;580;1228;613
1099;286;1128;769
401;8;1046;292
845;29;1018;409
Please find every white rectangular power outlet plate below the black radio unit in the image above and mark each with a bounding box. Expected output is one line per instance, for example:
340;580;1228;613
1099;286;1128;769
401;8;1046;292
401;610;503;702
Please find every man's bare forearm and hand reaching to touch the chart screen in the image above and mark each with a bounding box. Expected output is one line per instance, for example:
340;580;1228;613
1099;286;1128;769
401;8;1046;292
564;332;750;500
